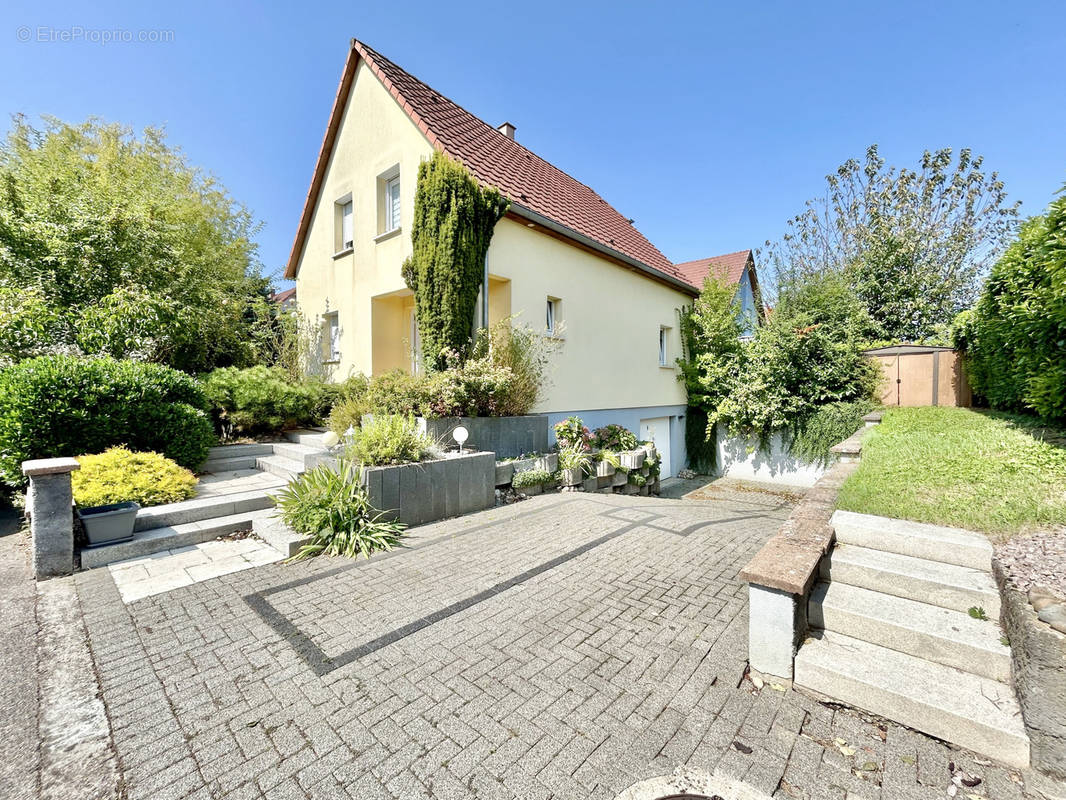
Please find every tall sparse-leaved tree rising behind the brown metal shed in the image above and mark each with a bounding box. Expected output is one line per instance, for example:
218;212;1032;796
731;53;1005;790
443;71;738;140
765;145;1019;341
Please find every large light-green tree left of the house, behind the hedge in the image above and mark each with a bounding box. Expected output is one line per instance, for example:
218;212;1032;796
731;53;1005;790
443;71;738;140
0;116;267;371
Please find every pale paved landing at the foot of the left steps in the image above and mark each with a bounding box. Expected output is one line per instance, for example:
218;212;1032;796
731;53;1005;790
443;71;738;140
108;537;284;603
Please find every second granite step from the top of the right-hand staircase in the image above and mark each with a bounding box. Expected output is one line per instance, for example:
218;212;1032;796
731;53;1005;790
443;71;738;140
819;544;1000;620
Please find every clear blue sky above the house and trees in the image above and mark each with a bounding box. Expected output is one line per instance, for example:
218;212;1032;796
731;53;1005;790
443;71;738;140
0;0;1066;288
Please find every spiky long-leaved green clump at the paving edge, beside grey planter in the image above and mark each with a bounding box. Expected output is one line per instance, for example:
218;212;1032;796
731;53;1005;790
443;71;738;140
275;460;406;561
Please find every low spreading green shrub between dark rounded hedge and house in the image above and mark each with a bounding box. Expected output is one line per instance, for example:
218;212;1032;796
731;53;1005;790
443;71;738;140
204;366;319;438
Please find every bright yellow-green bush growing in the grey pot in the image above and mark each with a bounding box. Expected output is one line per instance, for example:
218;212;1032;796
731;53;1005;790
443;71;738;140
71;447;196;507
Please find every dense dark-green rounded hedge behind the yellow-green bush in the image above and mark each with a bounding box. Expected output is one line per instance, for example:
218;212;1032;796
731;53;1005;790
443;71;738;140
0;355;215;487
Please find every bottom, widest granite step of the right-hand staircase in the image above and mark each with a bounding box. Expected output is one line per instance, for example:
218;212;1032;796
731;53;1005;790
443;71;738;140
795;630;1029;768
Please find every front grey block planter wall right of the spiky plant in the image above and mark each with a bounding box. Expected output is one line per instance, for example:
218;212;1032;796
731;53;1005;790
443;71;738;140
362;452;496;525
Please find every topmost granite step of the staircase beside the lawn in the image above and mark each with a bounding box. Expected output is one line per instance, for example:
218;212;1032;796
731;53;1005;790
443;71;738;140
829;511;992;572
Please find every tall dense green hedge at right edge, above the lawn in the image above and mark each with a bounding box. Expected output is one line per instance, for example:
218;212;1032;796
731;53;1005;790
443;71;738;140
956;181;1066;420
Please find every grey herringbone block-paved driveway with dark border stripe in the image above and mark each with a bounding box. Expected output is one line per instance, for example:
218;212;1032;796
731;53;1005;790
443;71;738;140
62;491;1044;800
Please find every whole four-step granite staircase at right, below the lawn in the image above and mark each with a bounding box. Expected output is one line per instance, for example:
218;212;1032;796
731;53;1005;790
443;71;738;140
795;511;1029;767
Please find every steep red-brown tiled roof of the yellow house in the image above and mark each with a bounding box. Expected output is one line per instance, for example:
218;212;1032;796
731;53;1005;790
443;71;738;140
286;39;691;292
